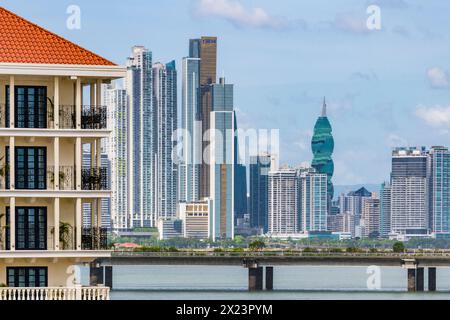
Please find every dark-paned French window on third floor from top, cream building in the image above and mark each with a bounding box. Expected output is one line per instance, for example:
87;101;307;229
6;207;47;250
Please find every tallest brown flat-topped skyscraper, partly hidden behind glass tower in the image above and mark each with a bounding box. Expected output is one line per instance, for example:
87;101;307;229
189;37;217;198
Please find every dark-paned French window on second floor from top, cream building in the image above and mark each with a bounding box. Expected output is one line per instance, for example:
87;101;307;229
6;147;47;190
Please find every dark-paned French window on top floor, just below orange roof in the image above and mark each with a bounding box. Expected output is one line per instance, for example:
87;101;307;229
5;86;47;129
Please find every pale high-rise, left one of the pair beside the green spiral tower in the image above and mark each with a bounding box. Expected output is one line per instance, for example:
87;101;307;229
268;168;301;235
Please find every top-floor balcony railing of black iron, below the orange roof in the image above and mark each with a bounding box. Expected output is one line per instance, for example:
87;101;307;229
0;103;107;130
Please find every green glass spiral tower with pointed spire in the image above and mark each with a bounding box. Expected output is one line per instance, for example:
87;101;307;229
311;98;334;200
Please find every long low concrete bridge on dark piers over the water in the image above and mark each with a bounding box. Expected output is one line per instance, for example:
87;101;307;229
90;251;450;291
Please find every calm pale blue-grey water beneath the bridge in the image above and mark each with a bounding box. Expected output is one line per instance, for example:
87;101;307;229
82;266;450;300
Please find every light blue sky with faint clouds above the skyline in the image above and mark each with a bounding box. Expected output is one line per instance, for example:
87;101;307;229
0;0;450;185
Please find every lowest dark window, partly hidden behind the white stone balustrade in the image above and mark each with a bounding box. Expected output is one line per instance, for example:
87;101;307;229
6;267;48;288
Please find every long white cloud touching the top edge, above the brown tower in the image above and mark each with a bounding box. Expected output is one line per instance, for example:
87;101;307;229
196;0;291;30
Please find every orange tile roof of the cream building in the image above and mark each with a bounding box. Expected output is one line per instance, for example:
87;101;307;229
0;7;116;66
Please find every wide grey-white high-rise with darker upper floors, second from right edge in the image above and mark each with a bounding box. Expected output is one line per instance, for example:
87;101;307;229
391;147;429;236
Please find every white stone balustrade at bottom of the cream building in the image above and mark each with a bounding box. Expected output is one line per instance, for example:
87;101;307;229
0;287;109;300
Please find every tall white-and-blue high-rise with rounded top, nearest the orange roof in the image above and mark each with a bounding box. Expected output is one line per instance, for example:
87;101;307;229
126;46;157;227
